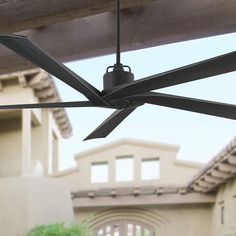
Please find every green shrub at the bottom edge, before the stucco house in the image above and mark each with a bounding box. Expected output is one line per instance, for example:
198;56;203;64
27;224;91;236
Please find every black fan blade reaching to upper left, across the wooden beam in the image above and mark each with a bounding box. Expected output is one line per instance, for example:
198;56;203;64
0;34;106;104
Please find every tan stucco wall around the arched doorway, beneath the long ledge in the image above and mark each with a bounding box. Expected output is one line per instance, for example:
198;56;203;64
75;205;211;236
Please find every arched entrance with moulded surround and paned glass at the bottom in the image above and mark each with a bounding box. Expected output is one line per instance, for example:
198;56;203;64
86;207;170;236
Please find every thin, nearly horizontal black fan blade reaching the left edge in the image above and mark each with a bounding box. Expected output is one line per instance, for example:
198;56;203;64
0;101;109;110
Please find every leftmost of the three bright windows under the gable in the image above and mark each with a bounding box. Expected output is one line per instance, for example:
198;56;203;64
91;162;108;183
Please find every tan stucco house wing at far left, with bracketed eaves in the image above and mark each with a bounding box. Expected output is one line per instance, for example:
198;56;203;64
0;69;73;236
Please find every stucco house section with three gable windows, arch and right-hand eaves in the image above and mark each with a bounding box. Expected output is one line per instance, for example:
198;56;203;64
56;139;236;236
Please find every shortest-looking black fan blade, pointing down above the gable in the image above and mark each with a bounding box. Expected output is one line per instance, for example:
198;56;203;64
84;106;137;141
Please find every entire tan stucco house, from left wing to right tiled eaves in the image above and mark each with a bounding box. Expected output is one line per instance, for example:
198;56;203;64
0;69;236;236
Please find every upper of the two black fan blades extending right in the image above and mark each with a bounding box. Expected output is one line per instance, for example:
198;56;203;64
103;52;236;101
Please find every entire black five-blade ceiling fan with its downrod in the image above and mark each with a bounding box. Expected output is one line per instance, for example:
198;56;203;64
0;0;236;140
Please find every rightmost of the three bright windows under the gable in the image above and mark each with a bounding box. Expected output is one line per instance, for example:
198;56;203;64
141;158;160;180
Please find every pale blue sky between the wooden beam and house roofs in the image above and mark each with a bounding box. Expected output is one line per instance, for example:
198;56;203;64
55;33;236;169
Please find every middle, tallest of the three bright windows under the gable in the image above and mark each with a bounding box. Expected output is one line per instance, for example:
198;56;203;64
116;156;134;182
